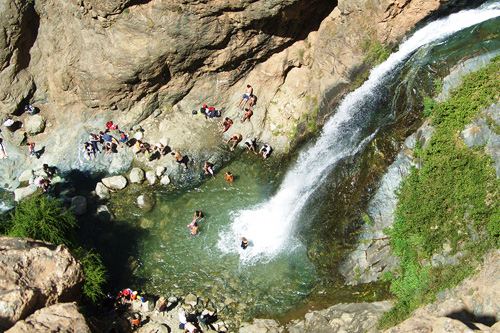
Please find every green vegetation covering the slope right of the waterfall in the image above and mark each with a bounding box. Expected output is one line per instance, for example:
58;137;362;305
380;58;500;328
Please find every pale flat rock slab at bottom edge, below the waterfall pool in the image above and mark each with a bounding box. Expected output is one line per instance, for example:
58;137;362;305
288;301;392;333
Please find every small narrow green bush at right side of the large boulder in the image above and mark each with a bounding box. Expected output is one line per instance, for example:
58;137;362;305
73;248;106;304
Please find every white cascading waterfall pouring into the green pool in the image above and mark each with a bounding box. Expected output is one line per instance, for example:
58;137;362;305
218;2;500;263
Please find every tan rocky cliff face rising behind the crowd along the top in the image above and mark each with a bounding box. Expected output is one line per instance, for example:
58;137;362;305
0;0;460;189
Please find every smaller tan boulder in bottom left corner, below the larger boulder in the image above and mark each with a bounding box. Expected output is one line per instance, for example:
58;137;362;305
7;303;91;333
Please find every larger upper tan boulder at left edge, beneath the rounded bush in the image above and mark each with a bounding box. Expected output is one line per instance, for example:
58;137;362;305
0;237;83;329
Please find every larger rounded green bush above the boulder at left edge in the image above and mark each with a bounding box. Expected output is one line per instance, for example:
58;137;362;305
7;195;77;247
